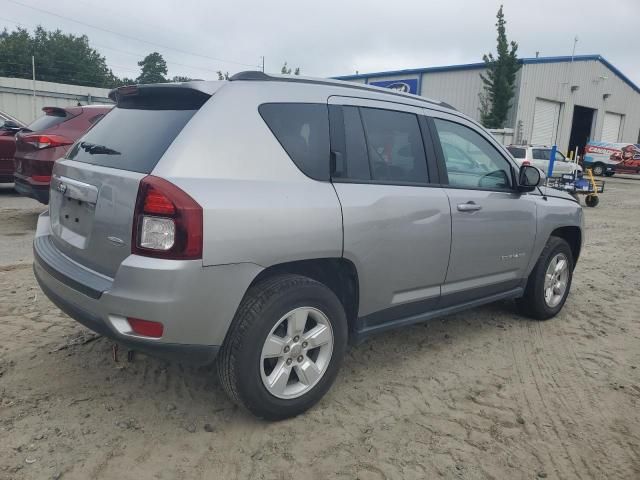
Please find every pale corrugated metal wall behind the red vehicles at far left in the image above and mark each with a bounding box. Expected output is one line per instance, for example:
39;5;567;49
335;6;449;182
0;77;113;124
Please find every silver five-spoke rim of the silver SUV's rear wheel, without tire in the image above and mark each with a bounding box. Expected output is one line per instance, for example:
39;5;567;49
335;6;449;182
260;307;333;399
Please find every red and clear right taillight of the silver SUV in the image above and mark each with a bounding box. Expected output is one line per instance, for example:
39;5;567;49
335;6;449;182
131;175;202;260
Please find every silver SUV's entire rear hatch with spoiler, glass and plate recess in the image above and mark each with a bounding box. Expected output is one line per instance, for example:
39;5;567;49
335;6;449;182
49;84;211;277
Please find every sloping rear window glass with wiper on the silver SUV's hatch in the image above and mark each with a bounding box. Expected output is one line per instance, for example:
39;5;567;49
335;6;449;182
67;107;197;173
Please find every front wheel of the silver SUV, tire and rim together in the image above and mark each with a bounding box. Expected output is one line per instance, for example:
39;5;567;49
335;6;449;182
516;237;574;320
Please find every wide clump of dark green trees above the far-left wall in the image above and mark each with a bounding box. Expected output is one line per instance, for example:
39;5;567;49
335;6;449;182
0;27;119;88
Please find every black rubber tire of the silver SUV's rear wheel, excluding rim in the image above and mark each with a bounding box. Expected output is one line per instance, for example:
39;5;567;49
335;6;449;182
218;275;348;420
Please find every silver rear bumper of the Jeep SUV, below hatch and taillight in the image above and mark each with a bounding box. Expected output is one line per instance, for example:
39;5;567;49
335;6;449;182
33;213;261;365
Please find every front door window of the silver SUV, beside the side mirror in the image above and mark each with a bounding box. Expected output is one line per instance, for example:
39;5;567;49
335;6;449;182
434;119;511;190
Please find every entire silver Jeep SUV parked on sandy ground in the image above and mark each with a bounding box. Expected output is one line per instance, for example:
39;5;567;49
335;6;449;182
34;72;582;419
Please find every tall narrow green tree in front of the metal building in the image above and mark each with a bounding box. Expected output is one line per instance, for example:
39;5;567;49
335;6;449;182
479;5;520;128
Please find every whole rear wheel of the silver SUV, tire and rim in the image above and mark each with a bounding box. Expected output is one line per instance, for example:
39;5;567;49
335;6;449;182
218;275;348;420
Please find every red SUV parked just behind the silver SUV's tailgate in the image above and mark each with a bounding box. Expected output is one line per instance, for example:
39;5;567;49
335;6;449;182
14;105;113;204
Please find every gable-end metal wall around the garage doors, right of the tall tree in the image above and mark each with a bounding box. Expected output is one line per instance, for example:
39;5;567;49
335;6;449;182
514;60;640;151
